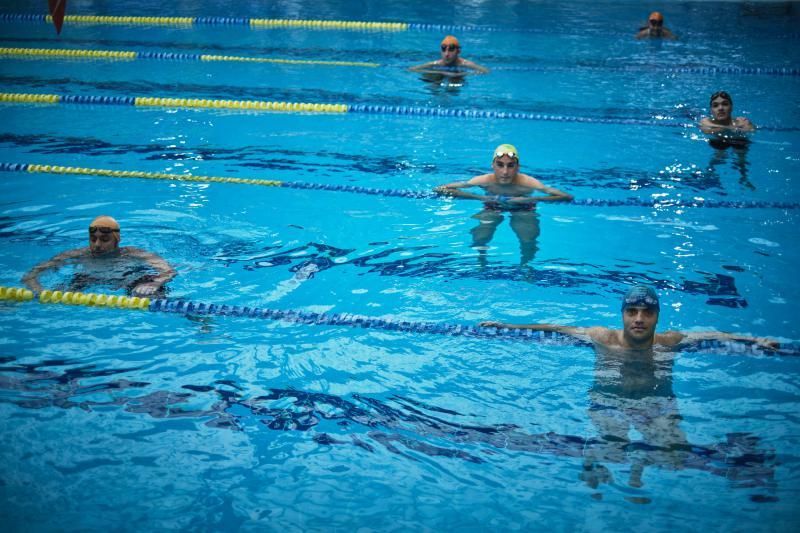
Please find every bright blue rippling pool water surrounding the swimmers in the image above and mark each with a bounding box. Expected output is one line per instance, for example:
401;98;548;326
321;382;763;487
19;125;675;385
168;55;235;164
0;2;800;531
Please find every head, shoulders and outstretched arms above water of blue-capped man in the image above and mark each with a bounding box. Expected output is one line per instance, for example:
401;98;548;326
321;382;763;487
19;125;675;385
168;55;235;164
481;285;780;351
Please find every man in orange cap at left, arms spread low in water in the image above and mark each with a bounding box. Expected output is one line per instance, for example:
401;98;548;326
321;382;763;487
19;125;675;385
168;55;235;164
22;216;176;297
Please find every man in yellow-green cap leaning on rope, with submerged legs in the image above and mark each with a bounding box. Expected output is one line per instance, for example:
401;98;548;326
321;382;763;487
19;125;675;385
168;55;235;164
434;144;572;265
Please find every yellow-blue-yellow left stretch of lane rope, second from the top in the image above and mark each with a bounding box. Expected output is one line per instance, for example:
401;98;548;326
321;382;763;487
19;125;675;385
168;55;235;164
0;48;381;68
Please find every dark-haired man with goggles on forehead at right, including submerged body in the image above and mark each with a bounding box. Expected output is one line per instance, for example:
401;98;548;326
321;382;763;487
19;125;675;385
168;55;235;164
699;91;756;189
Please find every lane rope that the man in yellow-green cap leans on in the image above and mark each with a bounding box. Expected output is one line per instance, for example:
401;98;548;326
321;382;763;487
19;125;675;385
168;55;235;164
0;162;800;209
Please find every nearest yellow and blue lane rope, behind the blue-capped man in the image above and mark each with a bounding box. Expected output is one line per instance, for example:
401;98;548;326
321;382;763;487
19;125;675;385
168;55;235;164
0;287;800;355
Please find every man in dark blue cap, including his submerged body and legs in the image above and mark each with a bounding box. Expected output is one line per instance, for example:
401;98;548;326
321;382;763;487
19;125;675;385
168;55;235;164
481;285;777;488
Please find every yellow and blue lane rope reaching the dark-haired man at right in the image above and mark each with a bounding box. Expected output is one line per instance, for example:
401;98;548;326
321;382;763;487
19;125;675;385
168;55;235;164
0;93;800;131
